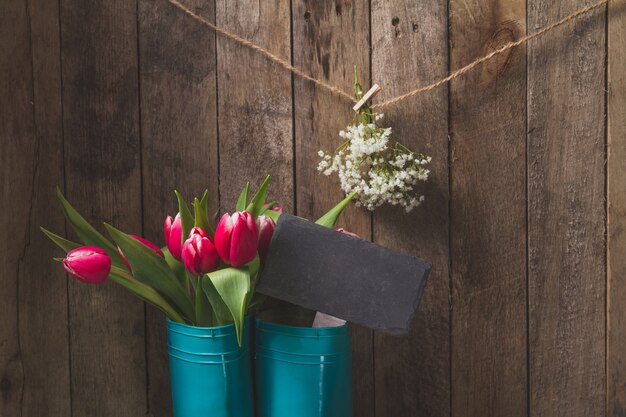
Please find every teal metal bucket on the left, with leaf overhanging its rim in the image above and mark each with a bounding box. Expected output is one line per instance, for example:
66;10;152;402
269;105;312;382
167;317;254;417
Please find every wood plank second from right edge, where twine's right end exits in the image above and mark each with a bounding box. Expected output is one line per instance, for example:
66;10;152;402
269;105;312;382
528;0;606;417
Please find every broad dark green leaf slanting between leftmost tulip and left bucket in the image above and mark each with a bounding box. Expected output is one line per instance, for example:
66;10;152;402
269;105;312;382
105;224;195;320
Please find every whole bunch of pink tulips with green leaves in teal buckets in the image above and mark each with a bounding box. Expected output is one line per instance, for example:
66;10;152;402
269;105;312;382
42;176;353;344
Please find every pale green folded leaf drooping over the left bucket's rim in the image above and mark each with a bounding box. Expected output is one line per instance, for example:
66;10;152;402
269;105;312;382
202;268;250;346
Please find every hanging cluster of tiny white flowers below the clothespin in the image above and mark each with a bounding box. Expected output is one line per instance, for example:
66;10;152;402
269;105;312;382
317;114;431;213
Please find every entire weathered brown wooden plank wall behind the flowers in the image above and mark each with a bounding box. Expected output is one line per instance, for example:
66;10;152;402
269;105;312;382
0;0;626;417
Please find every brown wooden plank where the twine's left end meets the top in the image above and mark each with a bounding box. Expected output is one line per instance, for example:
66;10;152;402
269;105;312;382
139;0;218;417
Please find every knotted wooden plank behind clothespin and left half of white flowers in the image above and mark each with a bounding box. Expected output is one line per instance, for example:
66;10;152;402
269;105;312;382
292;0;374;417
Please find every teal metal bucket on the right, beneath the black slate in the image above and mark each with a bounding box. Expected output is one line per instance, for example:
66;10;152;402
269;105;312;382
255;320;352;417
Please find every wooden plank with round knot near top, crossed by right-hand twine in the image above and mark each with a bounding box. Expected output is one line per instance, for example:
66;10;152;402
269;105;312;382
450;0;528;417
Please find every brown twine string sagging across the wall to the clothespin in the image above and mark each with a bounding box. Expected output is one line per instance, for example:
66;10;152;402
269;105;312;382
168;0;609;109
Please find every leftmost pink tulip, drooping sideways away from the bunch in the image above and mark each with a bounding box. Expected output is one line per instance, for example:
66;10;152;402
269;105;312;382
63;246;111;284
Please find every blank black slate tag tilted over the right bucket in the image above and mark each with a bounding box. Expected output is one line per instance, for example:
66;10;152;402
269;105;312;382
256;214;431;335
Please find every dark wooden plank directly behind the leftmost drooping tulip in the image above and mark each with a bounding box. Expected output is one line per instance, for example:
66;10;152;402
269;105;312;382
61;0;147;417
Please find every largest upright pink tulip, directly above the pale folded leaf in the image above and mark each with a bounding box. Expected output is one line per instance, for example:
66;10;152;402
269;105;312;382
215;211;259;267
